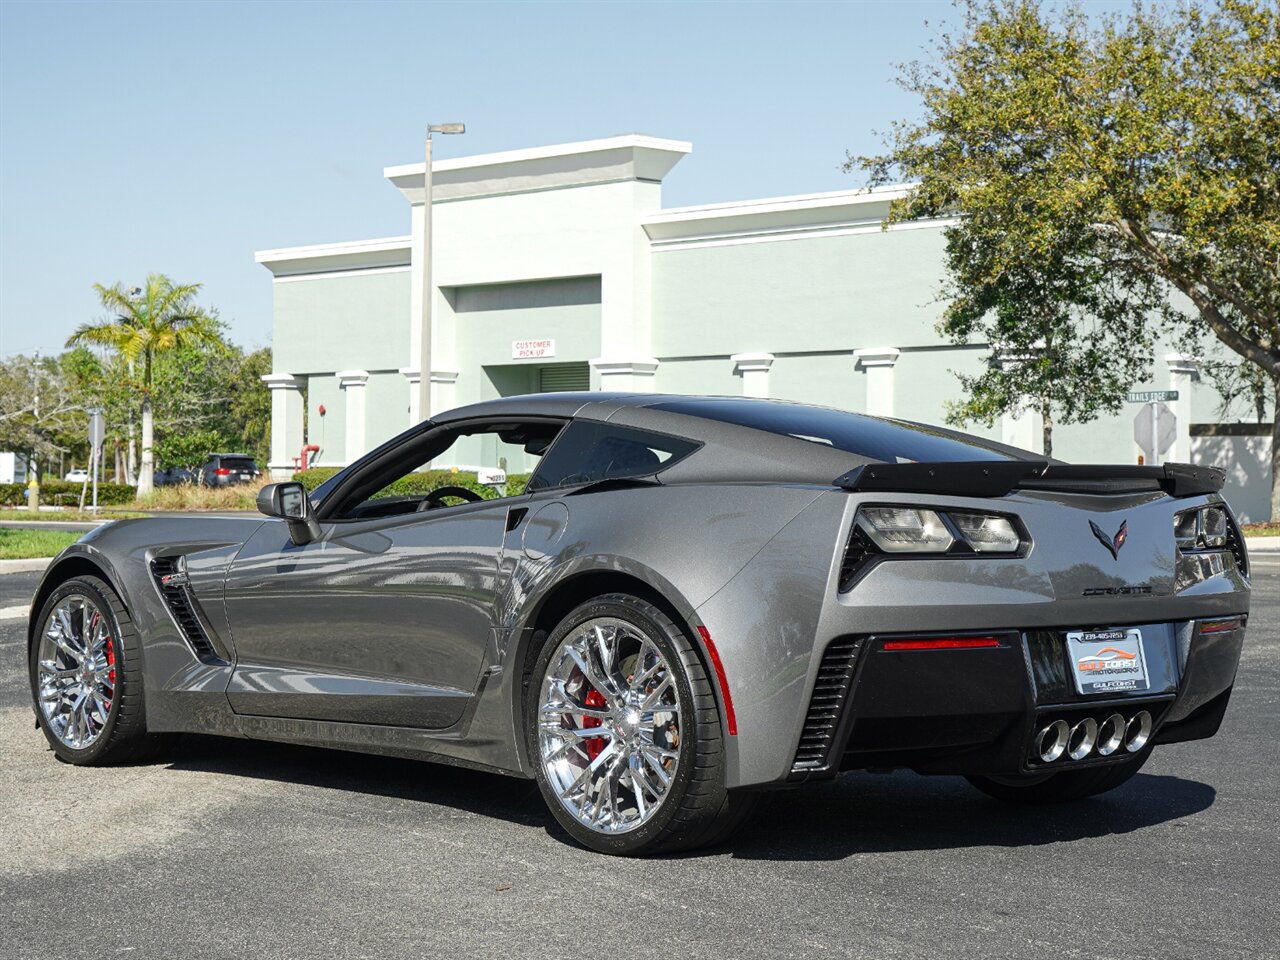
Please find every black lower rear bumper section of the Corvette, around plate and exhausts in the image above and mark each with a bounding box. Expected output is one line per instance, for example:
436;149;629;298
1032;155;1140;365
786;617;1244;783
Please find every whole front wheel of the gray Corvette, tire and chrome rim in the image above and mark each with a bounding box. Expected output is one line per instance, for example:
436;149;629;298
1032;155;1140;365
29;576;168;765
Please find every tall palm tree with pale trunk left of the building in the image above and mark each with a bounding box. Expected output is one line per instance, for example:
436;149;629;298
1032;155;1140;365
67;274;218;497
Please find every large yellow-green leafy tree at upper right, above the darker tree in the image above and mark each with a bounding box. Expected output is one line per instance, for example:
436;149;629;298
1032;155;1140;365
846;0;1280;516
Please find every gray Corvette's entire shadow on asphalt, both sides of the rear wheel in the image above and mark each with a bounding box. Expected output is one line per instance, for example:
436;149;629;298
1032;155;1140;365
157;735;1216;860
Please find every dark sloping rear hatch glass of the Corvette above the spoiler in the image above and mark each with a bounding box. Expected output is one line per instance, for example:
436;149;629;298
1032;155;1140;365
649;397;1021;463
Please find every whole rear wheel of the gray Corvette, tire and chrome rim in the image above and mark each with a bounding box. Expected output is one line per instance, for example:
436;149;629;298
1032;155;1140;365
526;594;755;856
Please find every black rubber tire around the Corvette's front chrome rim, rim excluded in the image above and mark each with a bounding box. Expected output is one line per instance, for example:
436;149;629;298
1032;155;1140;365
28;576;173;767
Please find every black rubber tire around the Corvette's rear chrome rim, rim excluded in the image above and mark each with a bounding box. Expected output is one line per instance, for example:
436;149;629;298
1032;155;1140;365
525;594;759;856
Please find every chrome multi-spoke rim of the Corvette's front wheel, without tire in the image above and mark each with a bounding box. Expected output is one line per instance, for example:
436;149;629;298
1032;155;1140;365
36;594;115;750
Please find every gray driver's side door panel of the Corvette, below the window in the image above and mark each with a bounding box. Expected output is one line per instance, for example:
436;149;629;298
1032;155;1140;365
225;498;524;728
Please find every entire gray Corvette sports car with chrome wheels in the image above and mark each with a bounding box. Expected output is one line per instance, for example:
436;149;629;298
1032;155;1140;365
28;393;1249;854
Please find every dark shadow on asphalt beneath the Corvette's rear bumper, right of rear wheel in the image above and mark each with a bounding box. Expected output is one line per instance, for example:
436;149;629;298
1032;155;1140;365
724;771;1217;860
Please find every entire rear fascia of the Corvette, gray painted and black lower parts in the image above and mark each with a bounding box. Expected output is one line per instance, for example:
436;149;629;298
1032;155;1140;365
696;493;1249;787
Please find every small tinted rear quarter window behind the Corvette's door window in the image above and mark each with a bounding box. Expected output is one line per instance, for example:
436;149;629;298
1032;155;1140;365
527;420;698;490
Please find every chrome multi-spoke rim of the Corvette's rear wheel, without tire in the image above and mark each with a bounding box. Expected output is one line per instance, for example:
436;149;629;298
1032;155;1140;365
538;617;681;833
